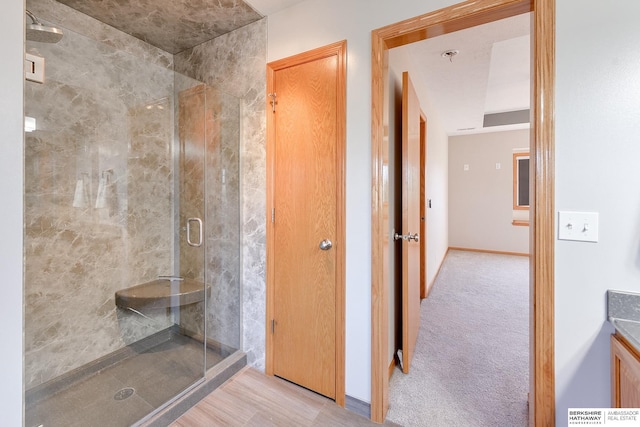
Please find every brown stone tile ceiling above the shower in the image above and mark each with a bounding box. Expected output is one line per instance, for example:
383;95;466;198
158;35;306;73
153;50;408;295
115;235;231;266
55;0;262;54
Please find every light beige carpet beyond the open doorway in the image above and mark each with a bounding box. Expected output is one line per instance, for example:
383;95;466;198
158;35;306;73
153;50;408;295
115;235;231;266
387;251;529;427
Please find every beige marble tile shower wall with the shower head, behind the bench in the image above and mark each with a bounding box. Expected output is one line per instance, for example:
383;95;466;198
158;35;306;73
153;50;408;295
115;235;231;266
24;0;174;389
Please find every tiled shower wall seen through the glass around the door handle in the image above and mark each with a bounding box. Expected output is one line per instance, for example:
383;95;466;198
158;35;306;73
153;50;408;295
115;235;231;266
179;84;241;349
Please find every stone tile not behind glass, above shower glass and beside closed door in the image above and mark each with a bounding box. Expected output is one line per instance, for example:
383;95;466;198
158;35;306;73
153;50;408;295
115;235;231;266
174;19;266;369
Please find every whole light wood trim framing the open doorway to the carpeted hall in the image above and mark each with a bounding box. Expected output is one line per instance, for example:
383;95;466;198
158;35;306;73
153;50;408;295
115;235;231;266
371;0;555;426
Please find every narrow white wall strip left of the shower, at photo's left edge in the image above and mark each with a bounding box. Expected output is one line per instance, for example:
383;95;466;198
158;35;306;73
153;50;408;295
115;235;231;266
0;1;25;426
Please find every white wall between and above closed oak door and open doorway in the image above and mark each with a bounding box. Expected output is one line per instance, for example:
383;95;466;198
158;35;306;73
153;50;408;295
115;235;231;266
267;0;455;402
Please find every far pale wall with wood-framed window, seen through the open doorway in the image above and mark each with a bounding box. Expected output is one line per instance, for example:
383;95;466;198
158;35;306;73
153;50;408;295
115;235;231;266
449;129;530;254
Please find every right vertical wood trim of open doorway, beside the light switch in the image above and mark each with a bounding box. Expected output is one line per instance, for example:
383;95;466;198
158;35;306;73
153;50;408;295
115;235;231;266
529;0;556;426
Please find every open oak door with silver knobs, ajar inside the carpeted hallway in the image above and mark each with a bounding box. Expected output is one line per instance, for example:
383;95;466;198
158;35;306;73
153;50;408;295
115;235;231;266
402;72;420;373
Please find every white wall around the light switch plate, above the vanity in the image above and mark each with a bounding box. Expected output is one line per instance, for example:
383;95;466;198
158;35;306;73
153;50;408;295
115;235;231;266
555;0;640;426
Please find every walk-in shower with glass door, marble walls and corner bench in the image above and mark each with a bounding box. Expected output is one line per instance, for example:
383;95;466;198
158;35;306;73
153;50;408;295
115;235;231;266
24;0;248;427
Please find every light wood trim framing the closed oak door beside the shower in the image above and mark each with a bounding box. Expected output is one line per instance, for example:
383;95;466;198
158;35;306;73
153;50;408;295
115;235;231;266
265;41;347;406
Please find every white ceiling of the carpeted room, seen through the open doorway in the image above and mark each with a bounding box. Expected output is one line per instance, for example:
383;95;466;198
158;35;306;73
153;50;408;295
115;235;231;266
398;14;531;135
